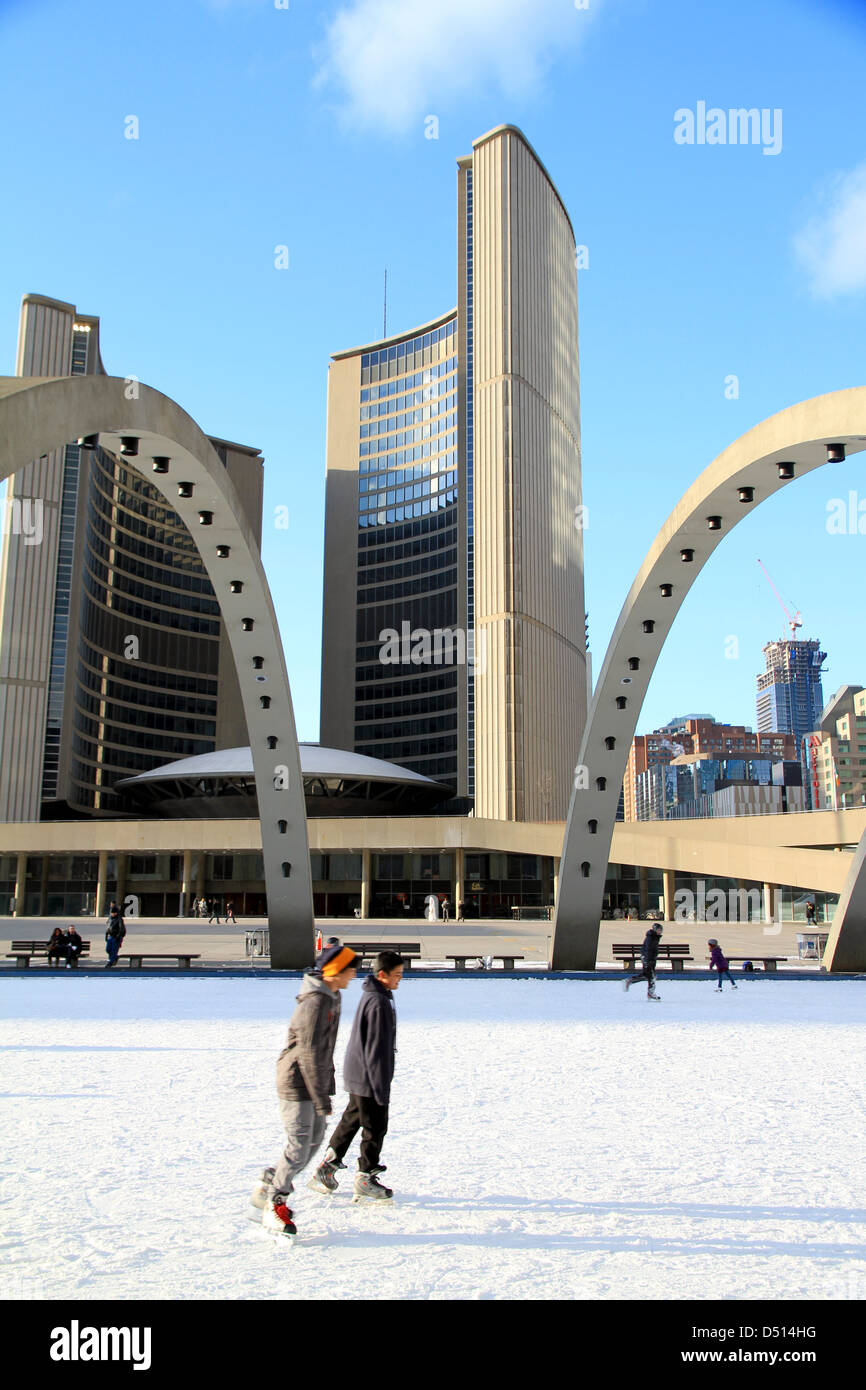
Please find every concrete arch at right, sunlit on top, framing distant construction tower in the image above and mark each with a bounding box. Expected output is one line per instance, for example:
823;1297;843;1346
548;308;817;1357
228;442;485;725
552;386;866;970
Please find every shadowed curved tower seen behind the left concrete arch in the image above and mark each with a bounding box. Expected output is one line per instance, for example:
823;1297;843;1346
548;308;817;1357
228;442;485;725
0;295;263;820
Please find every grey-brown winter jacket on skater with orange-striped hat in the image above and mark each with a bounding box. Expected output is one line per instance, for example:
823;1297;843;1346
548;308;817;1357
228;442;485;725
277;974;341;1115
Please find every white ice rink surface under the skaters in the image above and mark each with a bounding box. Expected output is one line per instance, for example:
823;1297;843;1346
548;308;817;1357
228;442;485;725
0;972;866;1302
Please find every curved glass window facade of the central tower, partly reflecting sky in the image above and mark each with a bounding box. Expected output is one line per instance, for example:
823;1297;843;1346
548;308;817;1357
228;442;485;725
354;316;459;787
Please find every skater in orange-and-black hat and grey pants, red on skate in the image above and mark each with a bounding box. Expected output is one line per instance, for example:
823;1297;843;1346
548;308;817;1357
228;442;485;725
252;944;361;1236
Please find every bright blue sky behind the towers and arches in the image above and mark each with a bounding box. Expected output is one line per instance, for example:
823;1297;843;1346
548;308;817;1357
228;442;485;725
0;0;866;738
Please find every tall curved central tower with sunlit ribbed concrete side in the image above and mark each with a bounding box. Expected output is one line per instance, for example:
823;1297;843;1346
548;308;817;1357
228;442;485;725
321;126;587;820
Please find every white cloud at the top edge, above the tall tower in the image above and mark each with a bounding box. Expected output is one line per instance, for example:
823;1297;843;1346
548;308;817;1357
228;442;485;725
317;0;602;133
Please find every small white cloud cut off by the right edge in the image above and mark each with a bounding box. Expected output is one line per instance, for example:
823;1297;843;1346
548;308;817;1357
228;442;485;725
794;164;866;299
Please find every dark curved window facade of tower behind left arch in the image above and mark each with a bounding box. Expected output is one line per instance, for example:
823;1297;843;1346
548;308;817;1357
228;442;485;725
66;449;220;812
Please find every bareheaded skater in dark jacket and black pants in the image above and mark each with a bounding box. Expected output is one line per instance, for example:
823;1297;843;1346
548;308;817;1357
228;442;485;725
307;951;403;1202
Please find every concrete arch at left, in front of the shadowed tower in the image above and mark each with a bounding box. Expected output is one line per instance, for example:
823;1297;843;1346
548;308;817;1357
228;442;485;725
0;377;314;969
